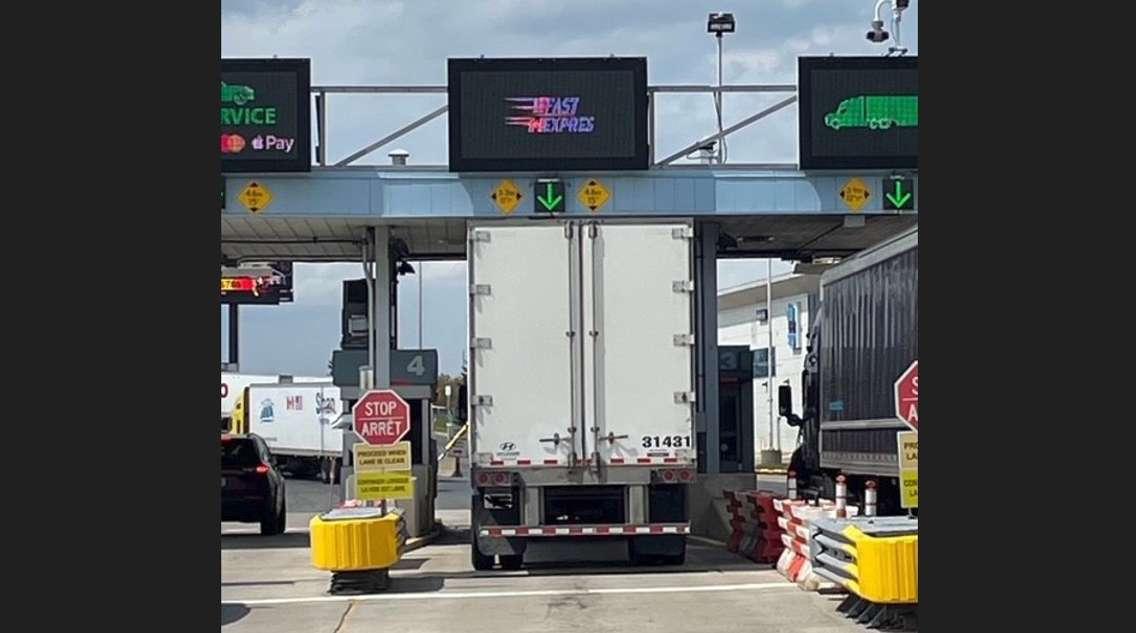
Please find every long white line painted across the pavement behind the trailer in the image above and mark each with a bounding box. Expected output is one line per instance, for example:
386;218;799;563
222;582;797;607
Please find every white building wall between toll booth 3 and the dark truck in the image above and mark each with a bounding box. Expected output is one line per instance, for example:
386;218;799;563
718;292;811;463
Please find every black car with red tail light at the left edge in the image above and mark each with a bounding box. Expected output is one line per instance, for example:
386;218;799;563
220;434;287;534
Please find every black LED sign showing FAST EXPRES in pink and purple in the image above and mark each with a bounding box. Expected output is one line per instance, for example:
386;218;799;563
449;57;649;172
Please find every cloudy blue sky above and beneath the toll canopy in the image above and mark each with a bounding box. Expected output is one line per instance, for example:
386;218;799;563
220;0;919;375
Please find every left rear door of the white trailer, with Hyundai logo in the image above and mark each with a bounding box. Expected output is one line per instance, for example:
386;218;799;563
469;224;579;466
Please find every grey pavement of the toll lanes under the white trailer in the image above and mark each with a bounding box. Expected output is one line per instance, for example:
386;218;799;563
220;470;876;633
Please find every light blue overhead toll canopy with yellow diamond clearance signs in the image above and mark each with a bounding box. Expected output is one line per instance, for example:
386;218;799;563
222;166;918;263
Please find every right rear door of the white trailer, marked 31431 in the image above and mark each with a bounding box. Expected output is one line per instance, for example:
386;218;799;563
582;223;695;465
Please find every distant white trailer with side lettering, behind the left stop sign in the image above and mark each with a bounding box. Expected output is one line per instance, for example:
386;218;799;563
234;382;343;481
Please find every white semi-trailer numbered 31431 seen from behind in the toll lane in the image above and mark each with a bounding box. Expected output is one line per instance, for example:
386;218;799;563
468;220;696;569
